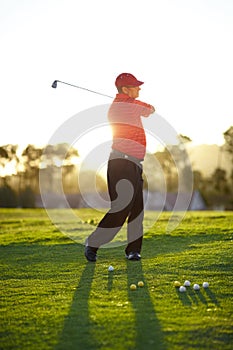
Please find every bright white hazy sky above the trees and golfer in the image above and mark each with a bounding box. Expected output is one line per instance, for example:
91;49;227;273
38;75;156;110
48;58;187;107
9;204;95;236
0;0;233;159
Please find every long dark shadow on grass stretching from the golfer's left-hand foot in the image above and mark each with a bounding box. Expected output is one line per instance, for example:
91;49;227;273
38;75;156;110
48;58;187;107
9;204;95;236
55;263;97;350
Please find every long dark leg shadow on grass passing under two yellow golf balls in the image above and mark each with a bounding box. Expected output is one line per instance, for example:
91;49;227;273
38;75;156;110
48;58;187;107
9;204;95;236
127;261;166;350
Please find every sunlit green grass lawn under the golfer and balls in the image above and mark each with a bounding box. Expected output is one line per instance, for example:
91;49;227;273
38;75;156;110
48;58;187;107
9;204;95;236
0;209;233;350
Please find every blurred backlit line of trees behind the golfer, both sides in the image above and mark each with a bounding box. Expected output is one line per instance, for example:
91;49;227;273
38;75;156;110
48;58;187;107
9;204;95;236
0;126;233;209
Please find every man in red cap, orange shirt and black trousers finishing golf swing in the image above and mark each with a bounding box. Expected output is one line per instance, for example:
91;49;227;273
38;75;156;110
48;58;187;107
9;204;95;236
85;73;155;262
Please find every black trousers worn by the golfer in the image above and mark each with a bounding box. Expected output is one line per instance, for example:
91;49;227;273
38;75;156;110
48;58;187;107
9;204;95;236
87;152;144;254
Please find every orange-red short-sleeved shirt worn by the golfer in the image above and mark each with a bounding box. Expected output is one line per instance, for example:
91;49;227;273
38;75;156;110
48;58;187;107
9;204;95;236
108;94;154;159
